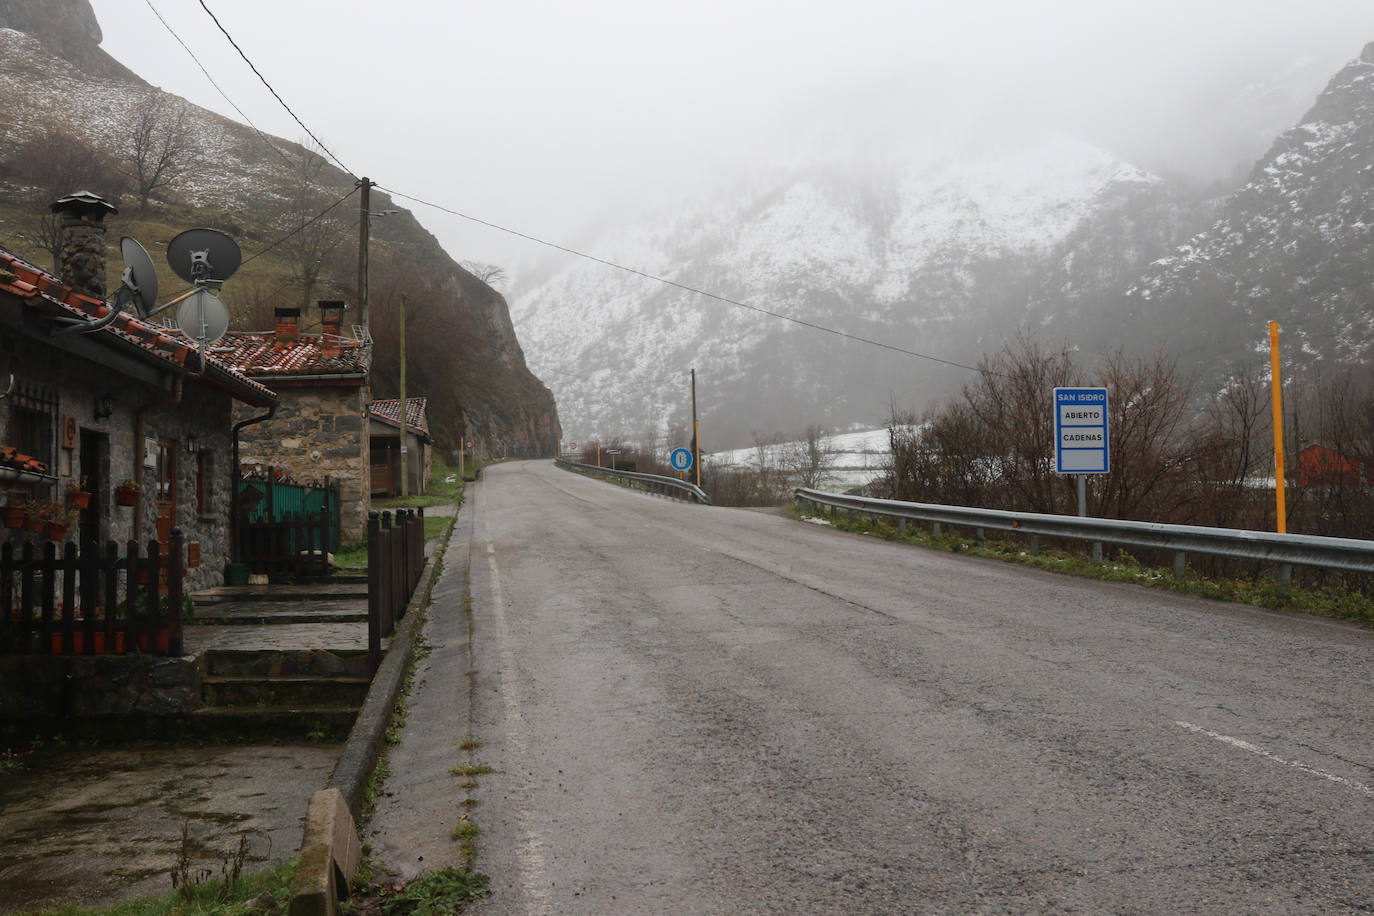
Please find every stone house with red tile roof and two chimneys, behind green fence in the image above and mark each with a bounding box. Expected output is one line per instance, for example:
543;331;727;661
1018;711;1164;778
212;301;372;541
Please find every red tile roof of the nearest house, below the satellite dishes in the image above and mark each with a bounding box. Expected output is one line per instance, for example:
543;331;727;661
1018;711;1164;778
0;247;276;407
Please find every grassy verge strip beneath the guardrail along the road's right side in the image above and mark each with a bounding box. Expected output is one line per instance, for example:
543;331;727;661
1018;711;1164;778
793;509;1374;623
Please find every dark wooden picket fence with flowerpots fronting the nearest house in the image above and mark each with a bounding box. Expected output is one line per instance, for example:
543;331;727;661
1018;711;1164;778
0;527;185;655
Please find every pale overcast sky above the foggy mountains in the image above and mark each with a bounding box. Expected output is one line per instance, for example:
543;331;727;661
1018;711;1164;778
92;0;1374;280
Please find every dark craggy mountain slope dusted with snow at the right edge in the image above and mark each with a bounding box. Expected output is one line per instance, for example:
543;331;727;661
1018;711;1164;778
1128;43;1374;369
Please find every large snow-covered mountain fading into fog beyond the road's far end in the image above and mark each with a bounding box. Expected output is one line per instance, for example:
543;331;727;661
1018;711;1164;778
513;133;1182;446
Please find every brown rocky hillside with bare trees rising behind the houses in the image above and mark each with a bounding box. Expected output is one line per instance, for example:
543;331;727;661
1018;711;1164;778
0;0;561;455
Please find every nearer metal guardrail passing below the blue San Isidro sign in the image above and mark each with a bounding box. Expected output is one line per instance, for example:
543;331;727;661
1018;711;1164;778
794;488;1374;579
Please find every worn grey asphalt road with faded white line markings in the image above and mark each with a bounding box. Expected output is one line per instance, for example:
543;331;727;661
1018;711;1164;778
463;463;1374;916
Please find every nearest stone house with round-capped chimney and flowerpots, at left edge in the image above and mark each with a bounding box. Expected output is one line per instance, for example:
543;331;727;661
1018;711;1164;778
0;194;276;589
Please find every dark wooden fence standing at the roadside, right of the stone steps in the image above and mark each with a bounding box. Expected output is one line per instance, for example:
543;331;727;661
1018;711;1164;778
367;508;425;672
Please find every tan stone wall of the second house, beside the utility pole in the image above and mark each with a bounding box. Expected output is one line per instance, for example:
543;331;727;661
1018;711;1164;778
235;386;372;541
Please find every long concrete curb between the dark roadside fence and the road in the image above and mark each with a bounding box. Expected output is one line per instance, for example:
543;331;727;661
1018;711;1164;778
328;515;456;820
